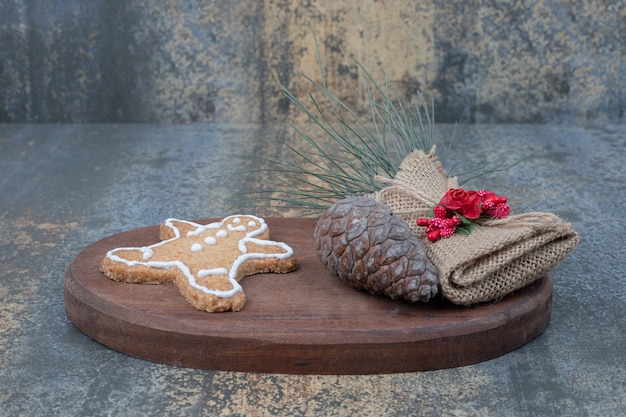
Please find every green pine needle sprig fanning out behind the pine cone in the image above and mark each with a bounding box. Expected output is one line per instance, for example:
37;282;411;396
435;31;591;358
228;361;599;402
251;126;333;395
241;40;446;214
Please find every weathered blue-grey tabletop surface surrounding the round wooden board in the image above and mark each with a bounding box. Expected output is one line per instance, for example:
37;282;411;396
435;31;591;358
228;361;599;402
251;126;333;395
0;124;626;417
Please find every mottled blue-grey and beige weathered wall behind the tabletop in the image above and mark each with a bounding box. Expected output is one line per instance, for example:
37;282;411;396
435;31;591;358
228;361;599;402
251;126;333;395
0;0;626;125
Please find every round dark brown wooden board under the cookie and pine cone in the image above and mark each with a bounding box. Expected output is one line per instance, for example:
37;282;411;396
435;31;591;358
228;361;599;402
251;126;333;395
65;218;552;374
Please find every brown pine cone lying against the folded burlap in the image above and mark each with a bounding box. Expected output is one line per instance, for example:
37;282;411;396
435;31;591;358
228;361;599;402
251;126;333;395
314;197;439;302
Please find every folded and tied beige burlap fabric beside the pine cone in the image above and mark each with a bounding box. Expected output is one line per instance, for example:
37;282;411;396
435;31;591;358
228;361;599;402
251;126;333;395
373;148;579;305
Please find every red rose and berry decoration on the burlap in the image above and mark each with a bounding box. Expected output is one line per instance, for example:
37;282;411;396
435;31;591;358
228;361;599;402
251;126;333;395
417;188;511;242
